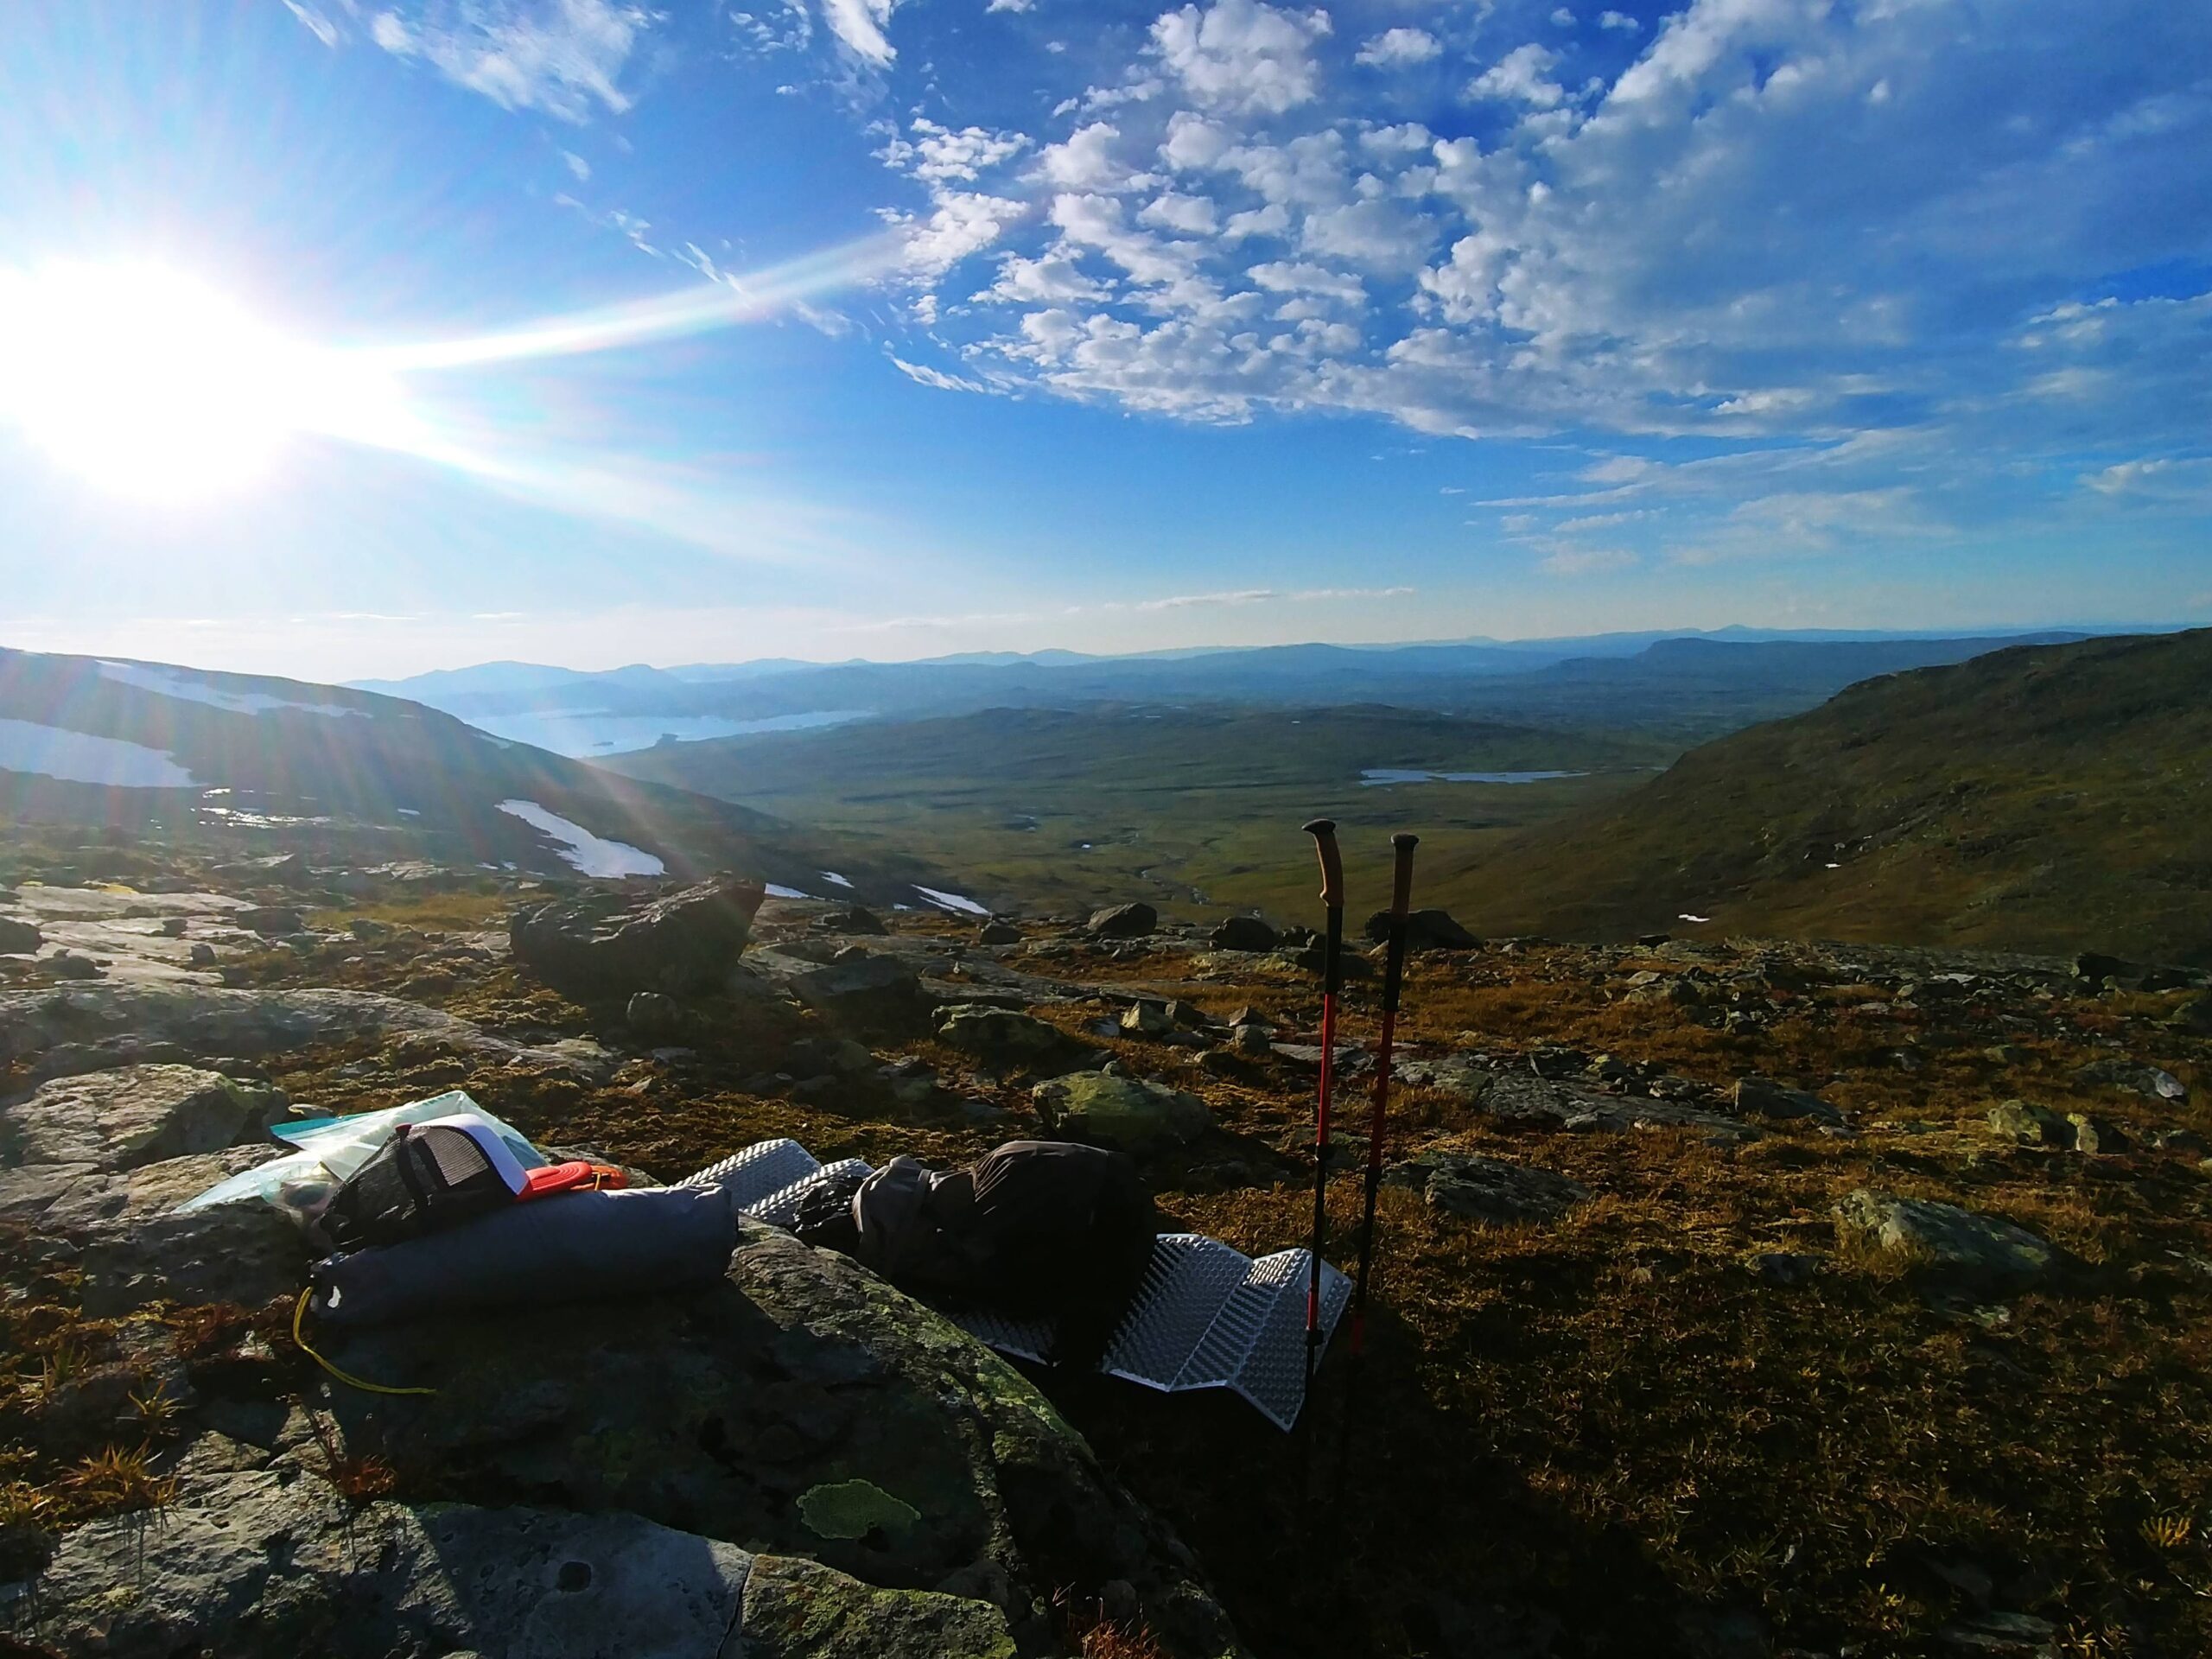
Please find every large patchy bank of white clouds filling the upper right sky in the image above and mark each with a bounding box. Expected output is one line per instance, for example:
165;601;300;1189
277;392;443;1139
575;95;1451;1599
831;0;2212;553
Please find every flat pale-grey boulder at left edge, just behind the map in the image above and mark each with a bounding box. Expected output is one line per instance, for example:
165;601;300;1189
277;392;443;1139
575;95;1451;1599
0;1066;285;1170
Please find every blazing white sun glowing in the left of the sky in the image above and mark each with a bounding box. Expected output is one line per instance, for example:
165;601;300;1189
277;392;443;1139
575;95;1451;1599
0;264;394;502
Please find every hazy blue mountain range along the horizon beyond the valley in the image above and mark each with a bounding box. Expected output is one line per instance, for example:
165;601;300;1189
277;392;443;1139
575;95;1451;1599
349;628;2123;757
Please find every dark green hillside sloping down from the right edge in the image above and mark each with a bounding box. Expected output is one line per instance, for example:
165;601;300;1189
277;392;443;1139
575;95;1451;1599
1431;631;2212;963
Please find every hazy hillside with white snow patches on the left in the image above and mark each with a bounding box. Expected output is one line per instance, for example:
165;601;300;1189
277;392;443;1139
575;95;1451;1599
0;651;969;902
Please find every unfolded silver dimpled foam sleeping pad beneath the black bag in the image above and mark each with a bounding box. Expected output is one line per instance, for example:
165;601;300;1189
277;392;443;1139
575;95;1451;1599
679;1141;1351;1429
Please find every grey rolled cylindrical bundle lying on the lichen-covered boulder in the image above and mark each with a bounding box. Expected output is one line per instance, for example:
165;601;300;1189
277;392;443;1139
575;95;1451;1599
312;1185;736;1327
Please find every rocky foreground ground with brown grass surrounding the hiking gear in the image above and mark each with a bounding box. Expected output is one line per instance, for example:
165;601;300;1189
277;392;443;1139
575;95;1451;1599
0;847;2212;1659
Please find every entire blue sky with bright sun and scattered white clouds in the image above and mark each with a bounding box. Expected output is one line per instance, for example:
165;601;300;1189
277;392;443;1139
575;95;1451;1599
0;0;2212;679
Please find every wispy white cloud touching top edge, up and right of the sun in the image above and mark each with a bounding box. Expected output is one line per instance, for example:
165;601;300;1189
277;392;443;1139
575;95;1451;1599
370;0;655;122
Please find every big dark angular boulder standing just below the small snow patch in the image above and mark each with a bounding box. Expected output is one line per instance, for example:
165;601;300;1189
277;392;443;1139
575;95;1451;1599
509;876;766;1000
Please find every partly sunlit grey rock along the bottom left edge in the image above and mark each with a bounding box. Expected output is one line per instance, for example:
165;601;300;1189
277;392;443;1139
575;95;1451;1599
17;1469;1013;1659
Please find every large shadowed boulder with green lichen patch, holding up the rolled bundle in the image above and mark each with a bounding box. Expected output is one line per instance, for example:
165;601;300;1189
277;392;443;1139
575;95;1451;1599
327;1221;1234;1659
